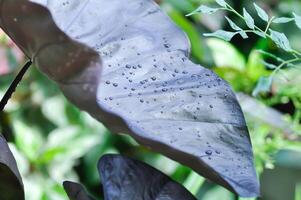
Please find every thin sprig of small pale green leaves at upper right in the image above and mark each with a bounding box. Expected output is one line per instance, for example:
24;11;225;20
187;0;301;96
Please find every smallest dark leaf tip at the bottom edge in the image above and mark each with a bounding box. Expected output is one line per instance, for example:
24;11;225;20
63;181;93;200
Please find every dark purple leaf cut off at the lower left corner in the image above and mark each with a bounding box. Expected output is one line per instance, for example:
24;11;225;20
0;135;24;200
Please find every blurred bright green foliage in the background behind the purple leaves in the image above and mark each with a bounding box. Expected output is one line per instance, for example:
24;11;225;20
0;0;301;200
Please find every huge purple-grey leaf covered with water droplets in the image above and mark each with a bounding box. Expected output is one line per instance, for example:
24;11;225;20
0;0;259;197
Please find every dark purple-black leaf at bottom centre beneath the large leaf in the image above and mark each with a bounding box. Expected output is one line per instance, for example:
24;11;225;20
98;155;196;200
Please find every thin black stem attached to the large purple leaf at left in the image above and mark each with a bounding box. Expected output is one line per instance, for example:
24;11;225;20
0;60;32;112
